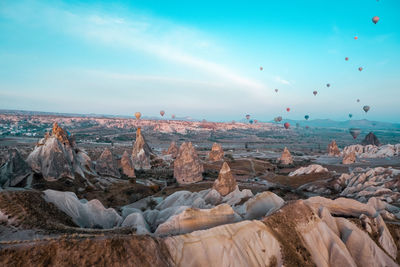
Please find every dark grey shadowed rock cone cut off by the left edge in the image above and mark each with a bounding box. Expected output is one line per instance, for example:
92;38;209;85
0;149;32;187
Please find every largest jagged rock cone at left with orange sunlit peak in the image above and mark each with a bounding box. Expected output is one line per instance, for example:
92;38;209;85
27;123;96;181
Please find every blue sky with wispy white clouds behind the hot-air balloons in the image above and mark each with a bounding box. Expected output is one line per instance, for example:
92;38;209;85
0;0;400;122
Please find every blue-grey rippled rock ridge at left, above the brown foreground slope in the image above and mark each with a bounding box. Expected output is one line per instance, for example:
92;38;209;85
44;190;122;229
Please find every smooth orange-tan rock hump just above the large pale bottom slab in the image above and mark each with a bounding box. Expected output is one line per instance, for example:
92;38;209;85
155;204;241;235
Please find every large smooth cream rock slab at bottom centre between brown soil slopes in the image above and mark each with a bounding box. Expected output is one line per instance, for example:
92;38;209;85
164;221;282;267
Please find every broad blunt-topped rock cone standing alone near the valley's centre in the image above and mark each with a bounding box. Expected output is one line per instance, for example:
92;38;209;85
174;142;204;184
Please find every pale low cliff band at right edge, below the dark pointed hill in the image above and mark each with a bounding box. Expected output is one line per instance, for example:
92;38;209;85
343;144;400;158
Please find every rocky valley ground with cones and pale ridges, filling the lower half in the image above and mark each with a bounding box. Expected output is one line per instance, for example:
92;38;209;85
0;122;400;266
